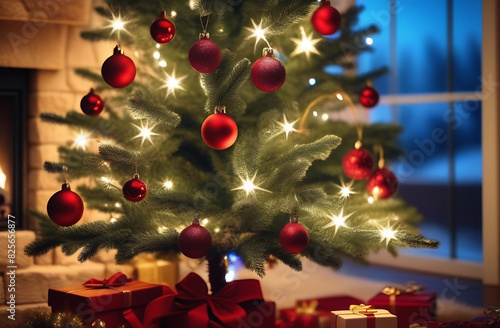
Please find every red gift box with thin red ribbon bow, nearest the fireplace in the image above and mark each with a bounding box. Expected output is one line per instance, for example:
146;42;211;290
48;272;163;328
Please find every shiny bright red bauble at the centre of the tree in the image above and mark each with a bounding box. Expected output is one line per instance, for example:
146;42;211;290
201;113;238;150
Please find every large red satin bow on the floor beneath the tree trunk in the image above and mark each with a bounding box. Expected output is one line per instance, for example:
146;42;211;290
144;273;263;328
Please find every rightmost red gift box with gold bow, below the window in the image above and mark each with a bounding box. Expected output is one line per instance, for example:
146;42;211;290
367;286;436;328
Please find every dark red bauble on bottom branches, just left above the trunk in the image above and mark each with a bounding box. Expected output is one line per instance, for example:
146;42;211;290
179;220;212;259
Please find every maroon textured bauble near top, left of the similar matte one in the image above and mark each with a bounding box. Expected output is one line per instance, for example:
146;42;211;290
188;38;222;73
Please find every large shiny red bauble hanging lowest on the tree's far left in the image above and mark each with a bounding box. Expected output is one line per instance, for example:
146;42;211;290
47;183;83;227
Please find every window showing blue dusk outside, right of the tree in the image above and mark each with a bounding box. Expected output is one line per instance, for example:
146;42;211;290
357;0;483;263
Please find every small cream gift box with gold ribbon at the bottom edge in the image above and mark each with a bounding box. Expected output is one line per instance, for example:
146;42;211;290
331;309;397;328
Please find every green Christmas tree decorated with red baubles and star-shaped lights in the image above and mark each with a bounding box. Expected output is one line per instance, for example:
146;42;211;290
26;0;438;291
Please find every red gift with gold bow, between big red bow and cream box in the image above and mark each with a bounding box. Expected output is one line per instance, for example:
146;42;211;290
277;296;362;328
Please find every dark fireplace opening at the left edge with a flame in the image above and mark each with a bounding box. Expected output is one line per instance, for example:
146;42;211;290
0;68;29;230
